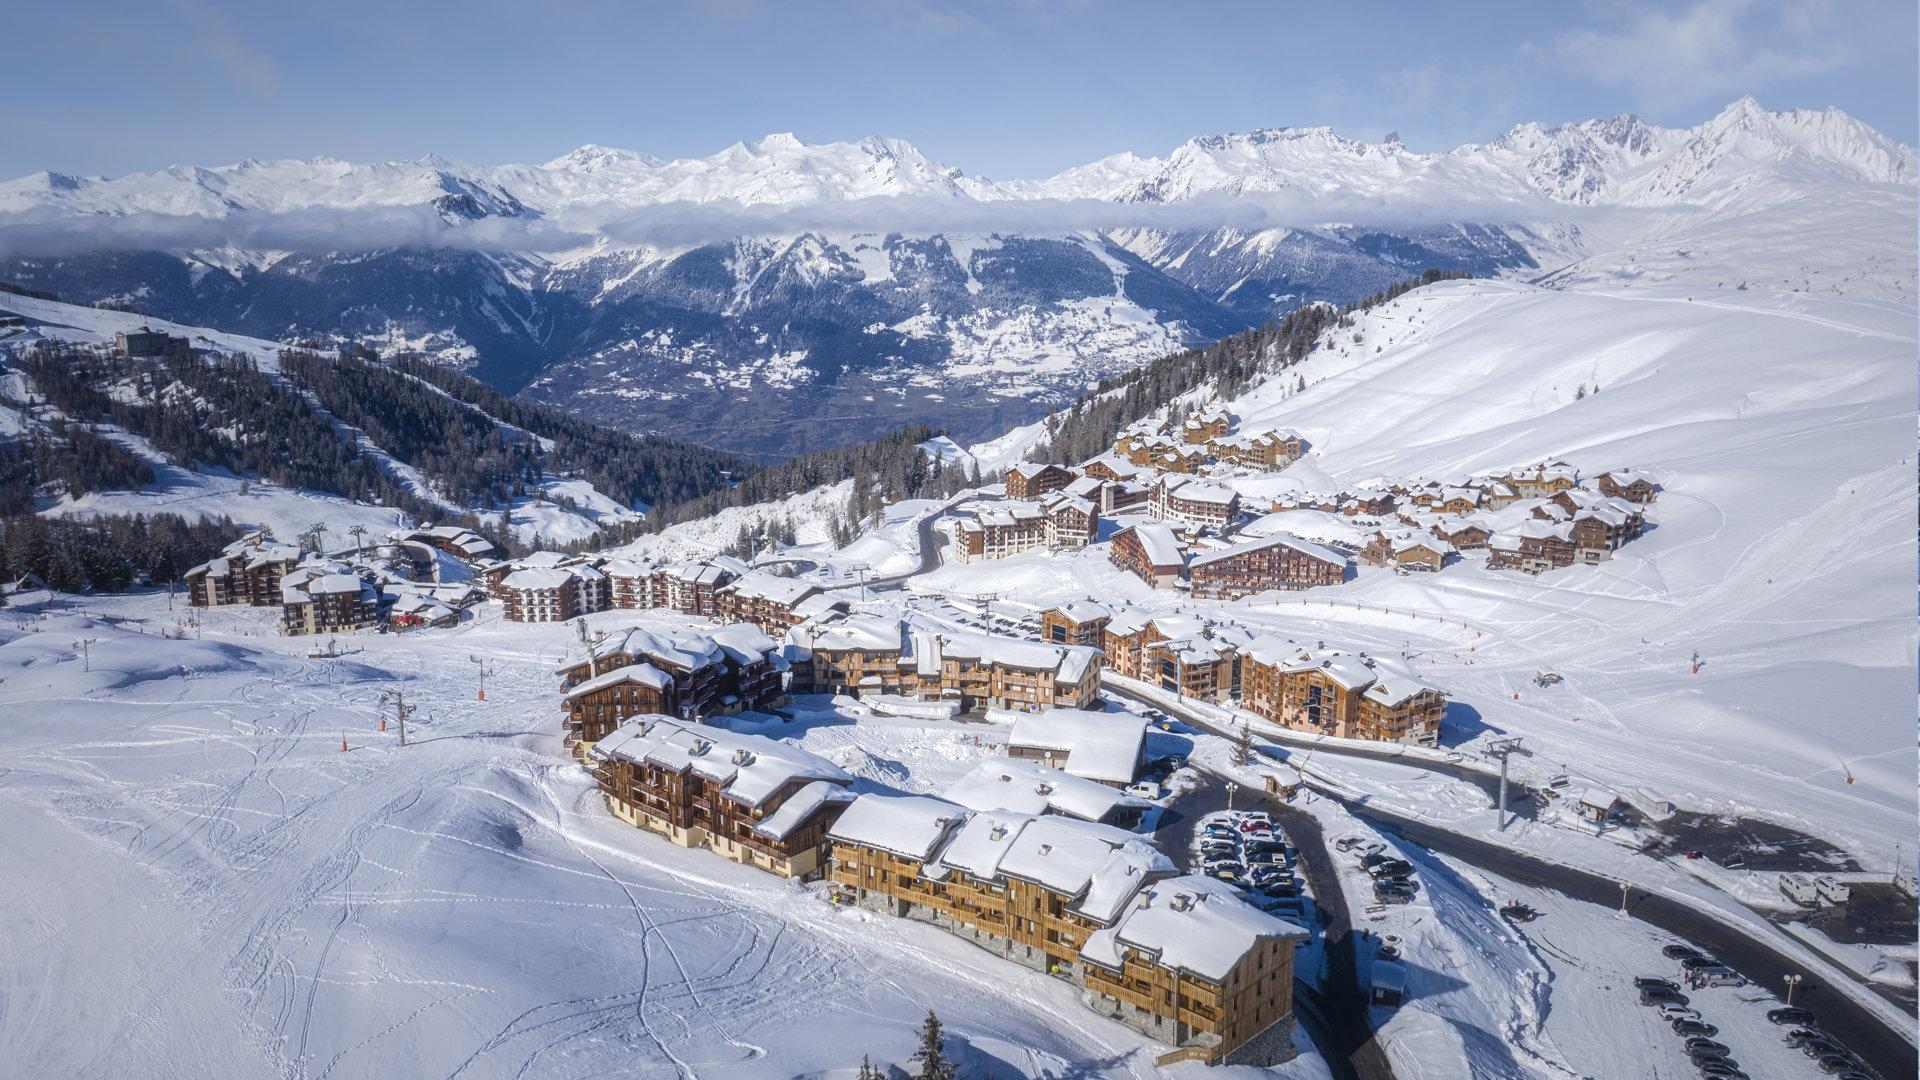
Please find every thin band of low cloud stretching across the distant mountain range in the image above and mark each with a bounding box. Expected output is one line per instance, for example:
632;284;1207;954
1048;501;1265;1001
0;190;1620;258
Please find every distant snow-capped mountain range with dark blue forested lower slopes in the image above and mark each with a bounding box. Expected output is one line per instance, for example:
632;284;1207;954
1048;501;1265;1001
0;98;1916;454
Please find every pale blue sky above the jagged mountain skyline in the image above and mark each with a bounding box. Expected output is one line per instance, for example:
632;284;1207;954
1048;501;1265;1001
0;0;1920;177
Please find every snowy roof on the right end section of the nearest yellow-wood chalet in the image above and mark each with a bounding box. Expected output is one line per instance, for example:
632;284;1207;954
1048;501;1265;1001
1087;876;1309;982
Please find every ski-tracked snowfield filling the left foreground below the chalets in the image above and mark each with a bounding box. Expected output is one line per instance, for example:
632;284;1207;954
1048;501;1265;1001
0;596;1323;1078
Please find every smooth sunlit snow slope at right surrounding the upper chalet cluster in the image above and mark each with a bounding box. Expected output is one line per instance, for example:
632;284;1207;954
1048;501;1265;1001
948;269;1916;869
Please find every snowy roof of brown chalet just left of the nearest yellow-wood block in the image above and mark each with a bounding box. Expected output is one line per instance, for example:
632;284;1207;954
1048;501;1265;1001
589;715;852;807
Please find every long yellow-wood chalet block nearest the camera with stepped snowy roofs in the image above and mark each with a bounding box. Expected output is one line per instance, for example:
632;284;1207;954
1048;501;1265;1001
828;794;1308;1065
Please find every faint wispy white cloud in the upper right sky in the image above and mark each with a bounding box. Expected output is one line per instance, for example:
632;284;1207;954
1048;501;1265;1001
1538;0;1851;110
